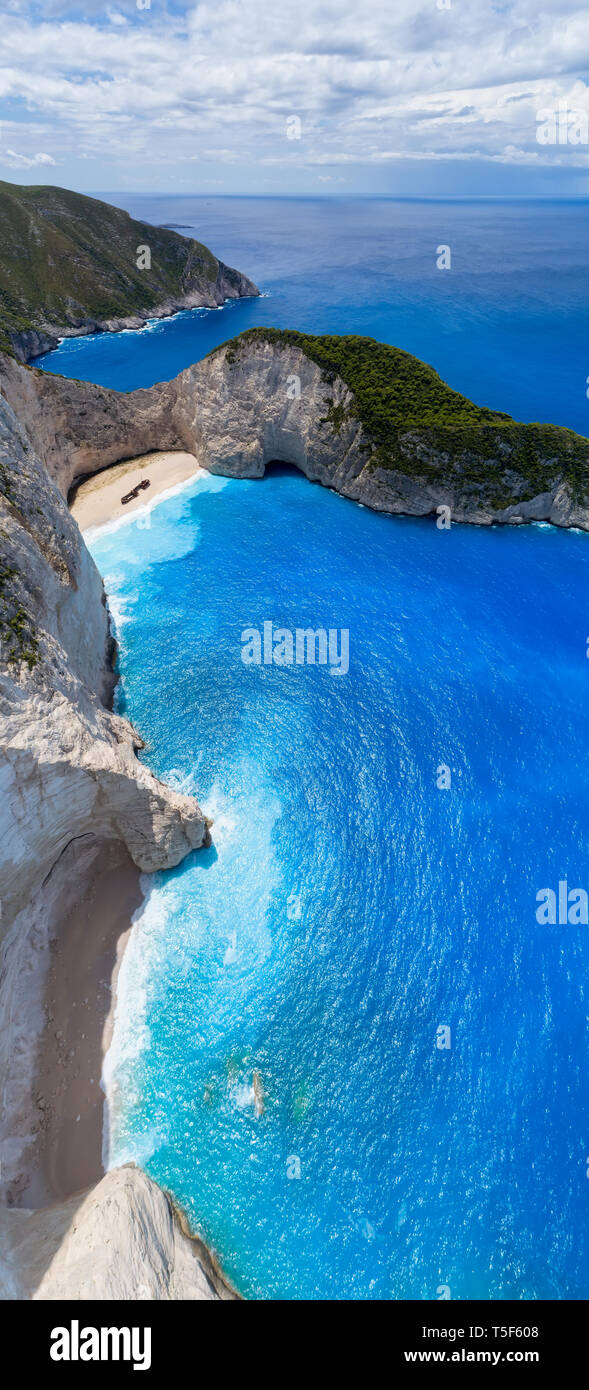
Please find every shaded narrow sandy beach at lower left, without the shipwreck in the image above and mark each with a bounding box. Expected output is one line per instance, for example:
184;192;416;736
24;842;143;1207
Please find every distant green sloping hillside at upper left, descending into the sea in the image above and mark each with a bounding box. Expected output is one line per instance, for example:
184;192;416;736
0;182;258;360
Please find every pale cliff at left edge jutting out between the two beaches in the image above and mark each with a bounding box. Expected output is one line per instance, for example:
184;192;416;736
0;402;206;919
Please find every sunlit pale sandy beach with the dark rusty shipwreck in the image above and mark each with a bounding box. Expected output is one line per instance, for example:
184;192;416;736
69;452;204;531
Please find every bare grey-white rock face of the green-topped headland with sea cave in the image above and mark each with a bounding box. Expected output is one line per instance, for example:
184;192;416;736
170;334;589;530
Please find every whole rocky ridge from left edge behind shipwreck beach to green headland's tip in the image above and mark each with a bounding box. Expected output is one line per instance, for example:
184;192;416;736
0;331;589;530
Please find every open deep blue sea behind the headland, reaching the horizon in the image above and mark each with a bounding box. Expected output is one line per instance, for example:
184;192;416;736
39;193;589;434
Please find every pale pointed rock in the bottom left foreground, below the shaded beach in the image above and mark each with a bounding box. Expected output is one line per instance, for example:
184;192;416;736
0;1166;236;1302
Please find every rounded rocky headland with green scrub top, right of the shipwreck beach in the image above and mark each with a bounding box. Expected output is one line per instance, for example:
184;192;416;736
170;329;589;530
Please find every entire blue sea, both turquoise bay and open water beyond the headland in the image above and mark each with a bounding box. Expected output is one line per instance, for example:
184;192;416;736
58;199;589;1300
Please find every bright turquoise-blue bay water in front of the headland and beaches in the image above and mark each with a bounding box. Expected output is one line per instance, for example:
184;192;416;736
84;470;588;1298
